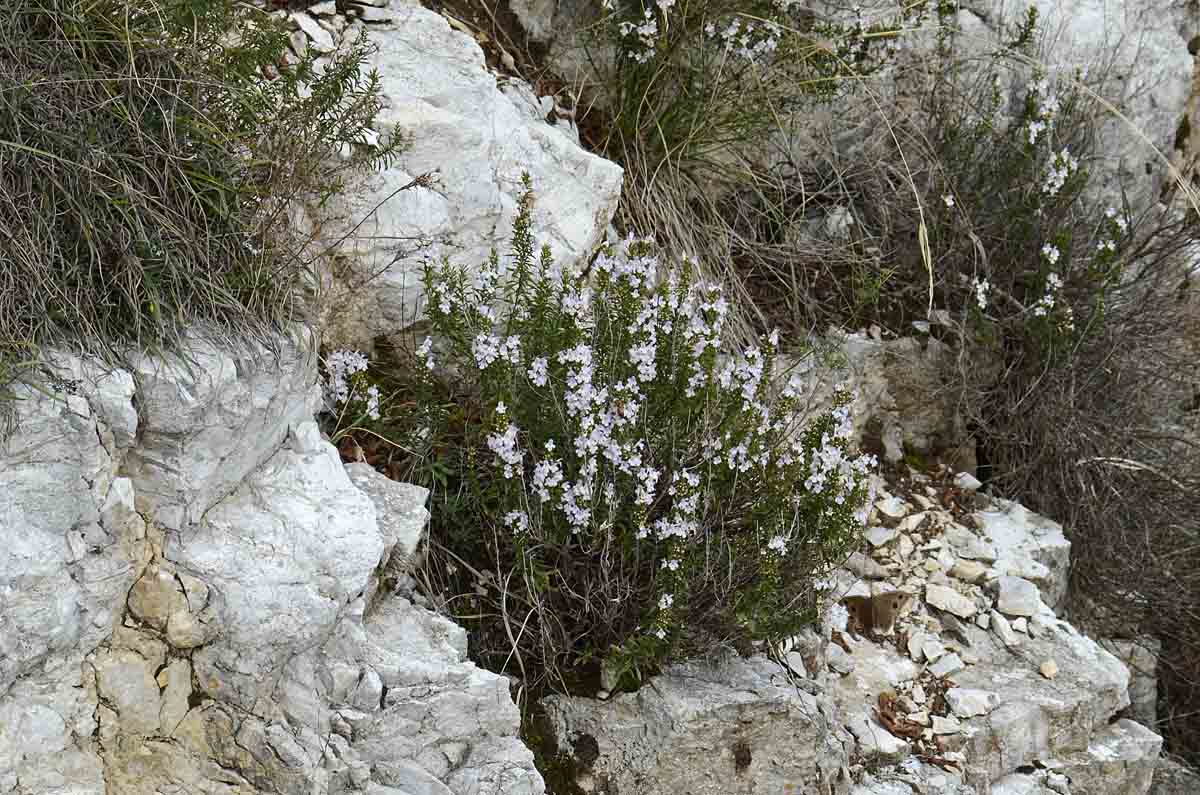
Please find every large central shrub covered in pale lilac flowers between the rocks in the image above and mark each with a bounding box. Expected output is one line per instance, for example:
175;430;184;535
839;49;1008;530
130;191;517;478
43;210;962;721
400;183;872;688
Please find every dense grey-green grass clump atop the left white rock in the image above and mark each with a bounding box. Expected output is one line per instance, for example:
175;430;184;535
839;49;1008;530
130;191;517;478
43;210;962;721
0;0;397;372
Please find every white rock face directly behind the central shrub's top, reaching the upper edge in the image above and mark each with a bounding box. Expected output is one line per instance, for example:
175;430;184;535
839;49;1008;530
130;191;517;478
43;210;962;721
322;2;623;348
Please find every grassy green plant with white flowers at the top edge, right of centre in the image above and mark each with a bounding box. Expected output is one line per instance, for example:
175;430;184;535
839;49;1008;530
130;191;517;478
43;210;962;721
594;0;929;171
